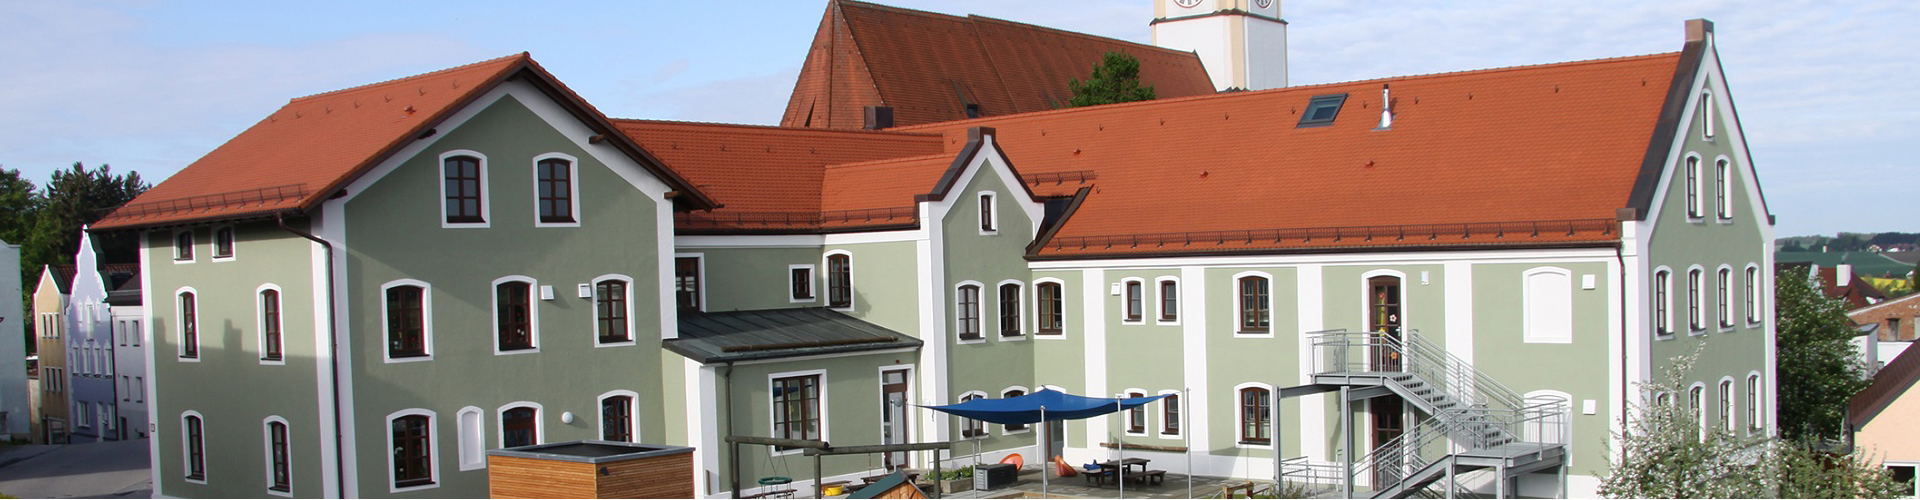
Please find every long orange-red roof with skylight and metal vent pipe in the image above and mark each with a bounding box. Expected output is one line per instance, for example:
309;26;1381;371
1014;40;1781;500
902;54;1680;256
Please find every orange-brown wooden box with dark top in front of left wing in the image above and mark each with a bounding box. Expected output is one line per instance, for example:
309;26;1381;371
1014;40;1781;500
488;440;693;498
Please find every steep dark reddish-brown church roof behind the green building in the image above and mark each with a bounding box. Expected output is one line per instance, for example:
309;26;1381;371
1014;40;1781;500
780;0;1213;129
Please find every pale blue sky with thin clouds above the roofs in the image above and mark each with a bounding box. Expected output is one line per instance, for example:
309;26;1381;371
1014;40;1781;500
0;0;1920;237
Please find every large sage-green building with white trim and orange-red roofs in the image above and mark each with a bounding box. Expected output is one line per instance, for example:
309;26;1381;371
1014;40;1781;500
96;8;1774;498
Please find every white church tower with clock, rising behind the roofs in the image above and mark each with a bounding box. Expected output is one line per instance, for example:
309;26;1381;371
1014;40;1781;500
1152;0;1286;90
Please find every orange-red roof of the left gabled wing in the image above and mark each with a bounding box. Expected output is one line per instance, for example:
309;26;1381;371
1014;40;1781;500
92;52;705;231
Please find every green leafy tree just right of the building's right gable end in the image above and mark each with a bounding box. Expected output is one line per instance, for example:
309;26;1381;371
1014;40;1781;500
1774;269;1870;442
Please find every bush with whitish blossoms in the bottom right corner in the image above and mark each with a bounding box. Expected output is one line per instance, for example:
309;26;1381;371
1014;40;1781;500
1599;344;1907;498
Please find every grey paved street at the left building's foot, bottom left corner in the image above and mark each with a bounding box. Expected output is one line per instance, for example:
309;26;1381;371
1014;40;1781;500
0;438;154;498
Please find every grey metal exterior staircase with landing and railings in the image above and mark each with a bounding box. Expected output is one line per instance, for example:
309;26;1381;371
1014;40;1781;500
1283;331;1567;498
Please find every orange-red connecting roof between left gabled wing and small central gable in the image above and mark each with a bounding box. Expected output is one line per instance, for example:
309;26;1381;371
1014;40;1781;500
614;119;950;233
